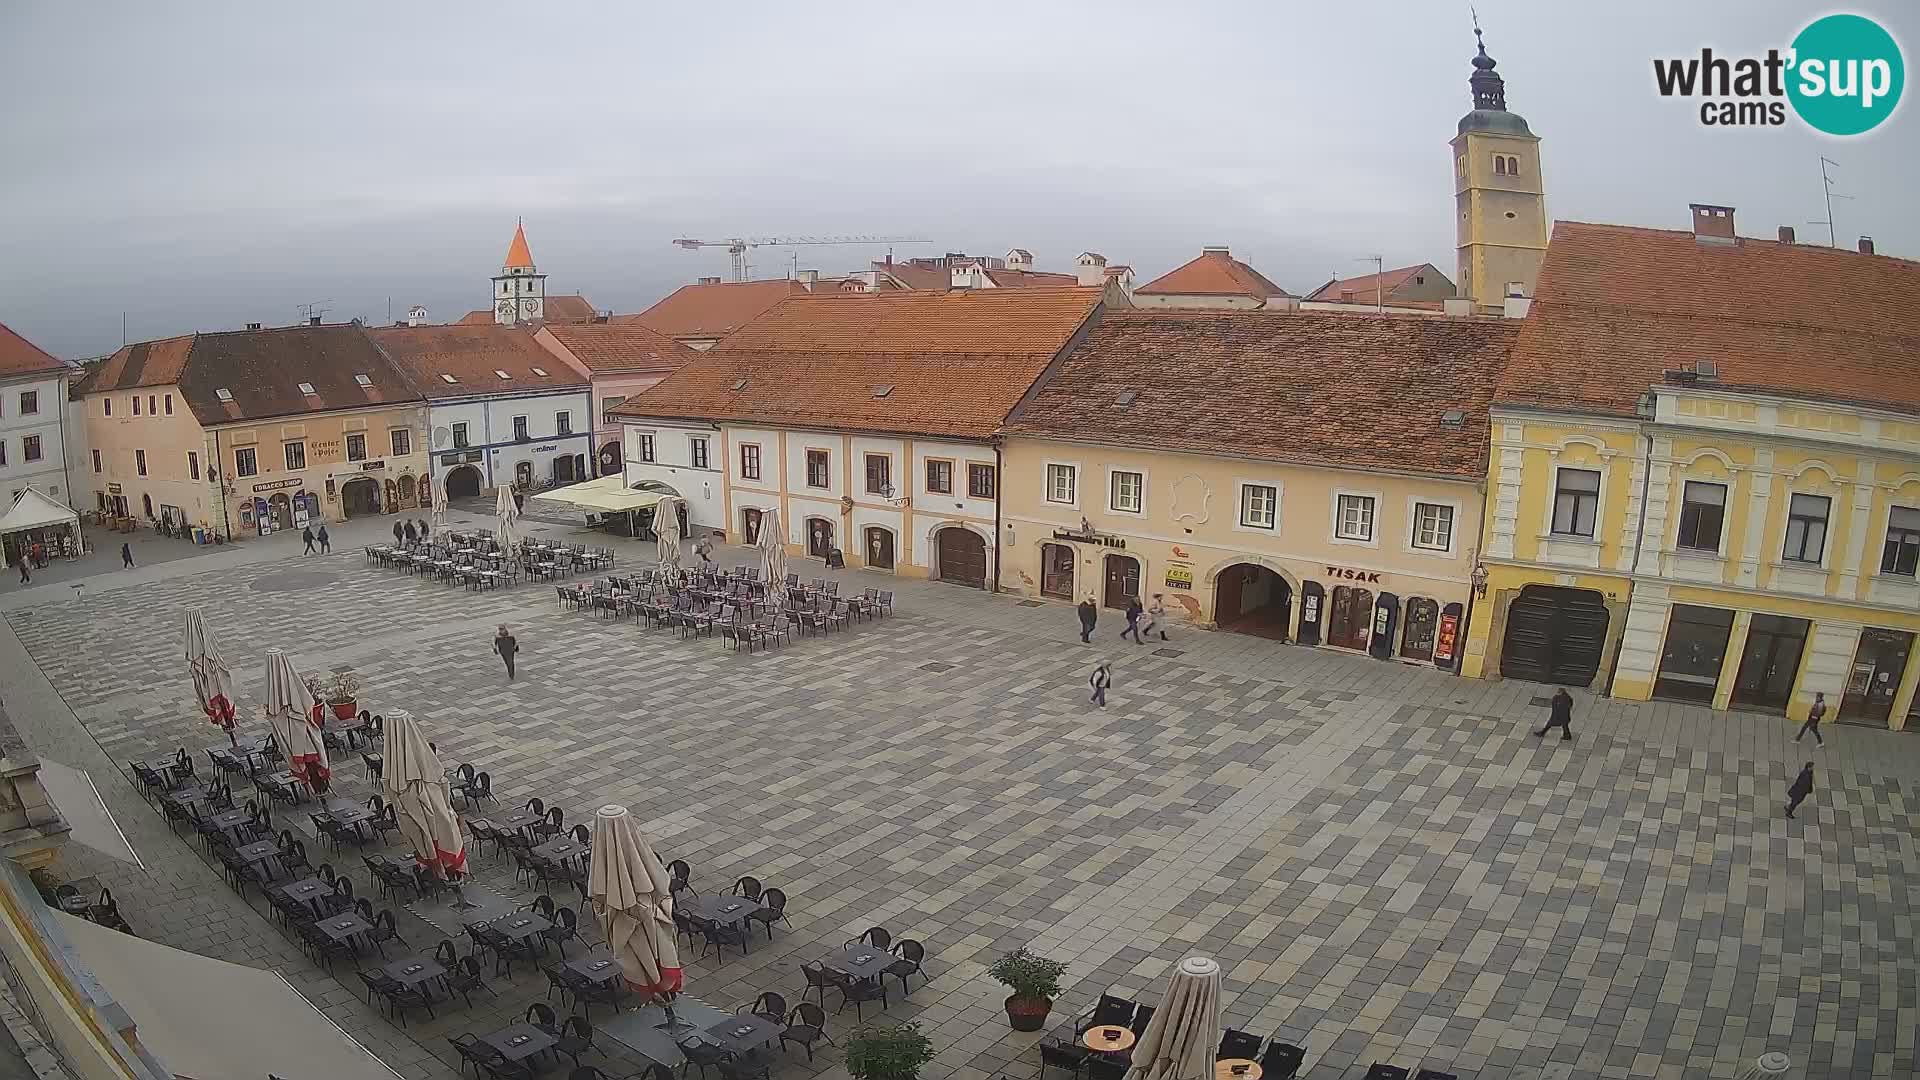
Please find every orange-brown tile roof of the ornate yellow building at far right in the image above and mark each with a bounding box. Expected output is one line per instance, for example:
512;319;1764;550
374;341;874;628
1498;221;1920;417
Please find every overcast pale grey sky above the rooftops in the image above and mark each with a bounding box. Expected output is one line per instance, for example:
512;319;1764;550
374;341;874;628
0;0;1920;357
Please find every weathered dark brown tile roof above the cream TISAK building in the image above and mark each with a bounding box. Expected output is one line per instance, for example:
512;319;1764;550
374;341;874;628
1006;309;1519;479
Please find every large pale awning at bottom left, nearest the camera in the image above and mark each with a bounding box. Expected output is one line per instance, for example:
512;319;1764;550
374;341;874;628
54;913;399;1080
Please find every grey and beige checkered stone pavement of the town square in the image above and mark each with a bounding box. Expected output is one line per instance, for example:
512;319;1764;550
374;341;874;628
0;526;1920;1080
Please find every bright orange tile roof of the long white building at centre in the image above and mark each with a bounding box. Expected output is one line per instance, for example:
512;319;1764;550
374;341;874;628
614;288;1102;438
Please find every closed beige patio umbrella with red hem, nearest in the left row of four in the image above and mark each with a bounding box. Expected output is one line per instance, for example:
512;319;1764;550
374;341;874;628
588;805;684;994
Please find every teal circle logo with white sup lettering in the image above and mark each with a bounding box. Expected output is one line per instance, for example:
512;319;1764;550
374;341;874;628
1788;15;1907;135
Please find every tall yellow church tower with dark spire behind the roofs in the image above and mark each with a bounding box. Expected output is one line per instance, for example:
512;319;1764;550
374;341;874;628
1453;27;1548;313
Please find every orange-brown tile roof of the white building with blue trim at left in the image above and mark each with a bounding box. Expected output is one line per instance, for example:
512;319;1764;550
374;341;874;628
371;327;588;400
